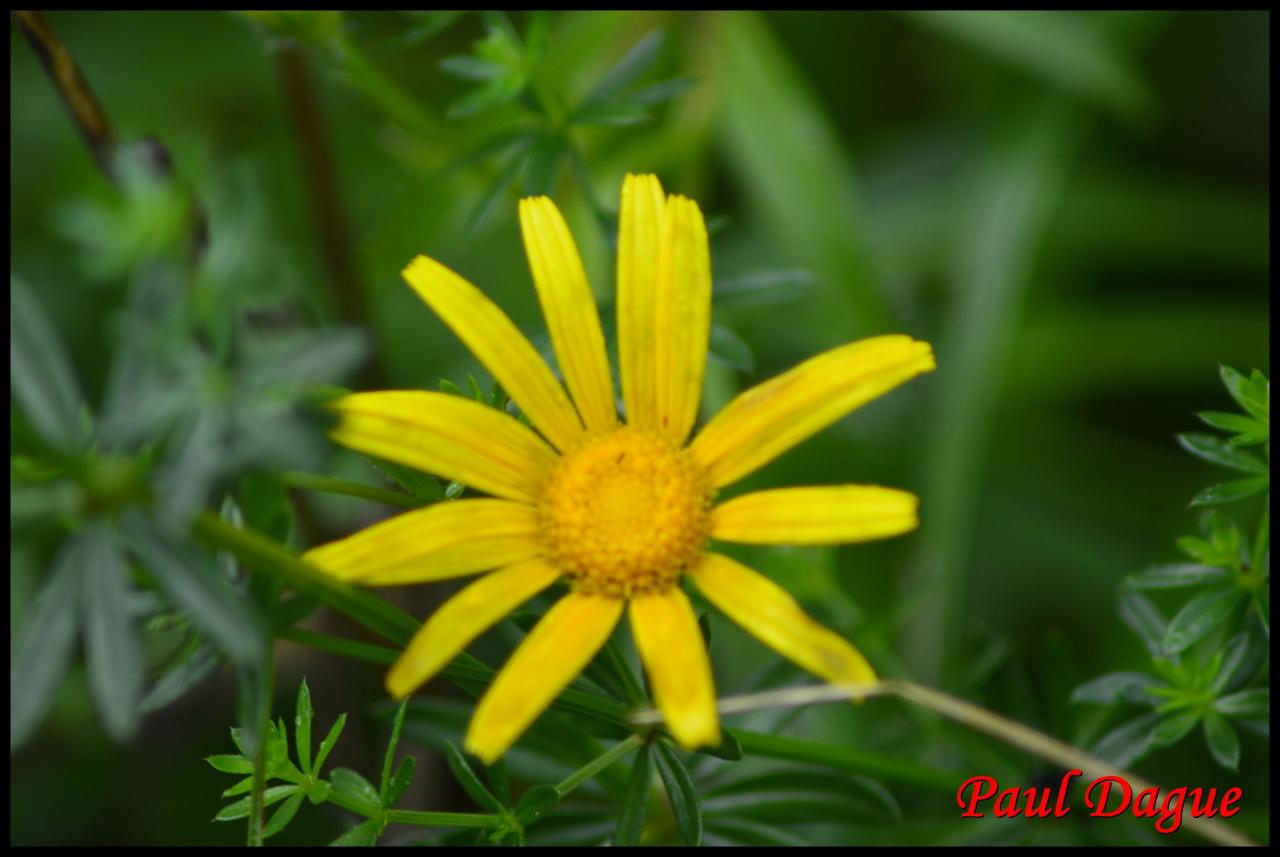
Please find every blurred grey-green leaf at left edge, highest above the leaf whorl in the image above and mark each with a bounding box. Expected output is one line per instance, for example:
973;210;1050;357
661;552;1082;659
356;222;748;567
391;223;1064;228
9;274;86;452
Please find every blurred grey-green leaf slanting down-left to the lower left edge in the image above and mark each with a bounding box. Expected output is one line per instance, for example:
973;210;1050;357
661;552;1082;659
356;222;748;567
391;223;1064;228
9;533;85;752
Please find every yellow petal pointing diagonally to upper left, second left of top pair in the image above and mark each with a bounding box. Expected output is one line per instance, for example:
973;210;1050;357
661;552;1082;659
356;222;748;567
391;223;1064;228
403;256;584;449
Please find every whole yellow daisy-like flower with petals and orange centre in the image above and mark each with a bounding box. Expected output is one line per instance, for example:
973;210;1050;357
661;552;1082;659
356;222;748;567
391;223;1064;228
306;175;933;762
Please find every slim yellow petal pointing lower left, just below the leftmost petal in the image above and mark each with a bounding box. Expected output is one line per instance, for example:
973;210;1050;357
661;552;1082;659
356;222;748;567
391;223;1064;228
387;559;559;698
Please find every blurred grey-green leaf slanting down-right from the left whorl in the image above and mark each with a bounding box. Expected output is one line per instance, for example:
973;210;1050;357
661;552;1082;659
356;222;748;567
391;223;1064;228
122;512;266;664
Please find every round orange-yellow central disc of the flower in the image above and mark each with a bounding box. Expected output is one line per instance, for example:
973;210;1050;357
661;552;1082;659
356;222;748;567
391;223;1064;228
540;427;713;596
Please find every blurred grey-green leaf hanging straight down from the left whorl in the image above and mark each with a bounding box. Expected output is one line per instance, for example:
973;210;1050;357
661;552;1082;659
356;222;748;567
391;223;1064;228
81;523;145;741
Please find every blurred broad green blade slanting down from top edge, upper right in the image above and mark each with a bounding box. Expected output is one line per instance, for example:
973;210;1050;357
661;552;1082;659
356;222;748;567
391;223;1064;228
909;10;1151;115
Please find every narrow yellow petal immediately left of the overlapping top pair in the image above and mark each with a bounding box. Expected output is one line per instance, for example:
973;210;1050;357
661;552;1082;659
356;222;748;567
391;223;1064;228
520;197;618;431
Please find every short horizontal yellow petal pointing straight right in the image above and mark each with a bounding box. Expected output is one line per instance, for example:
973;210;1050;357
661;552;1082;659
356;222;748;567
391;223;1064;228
712;485;918;545
